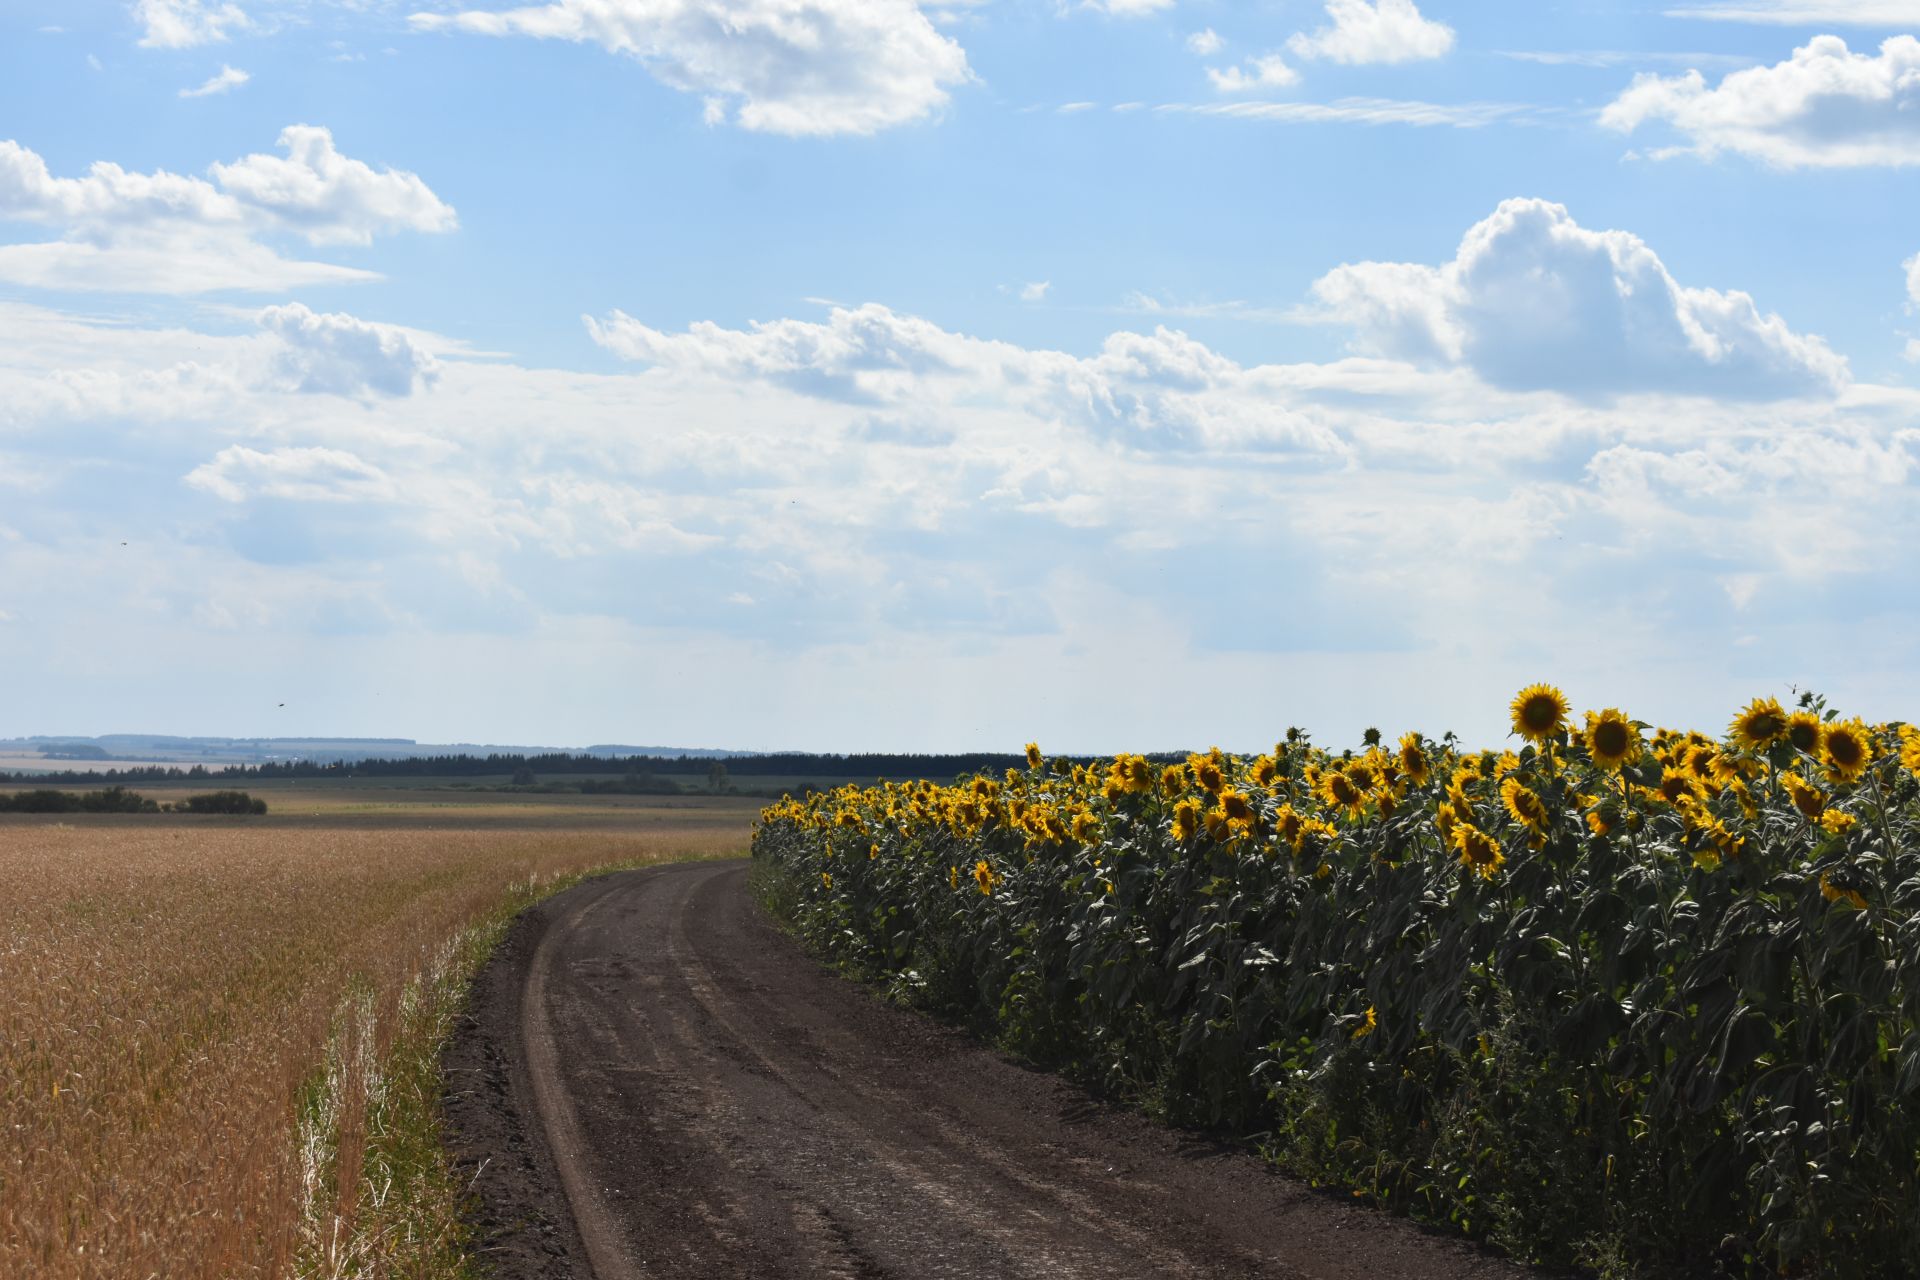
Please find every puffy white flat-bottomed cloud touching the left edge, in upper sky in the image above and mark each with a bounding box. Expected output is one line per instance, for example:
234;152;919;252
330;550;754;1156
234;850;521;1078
0;125;457;294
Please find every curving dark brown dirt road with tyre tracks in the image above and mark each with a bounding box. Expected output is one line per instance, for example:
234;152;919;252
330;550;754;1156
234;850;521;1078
447;862;1530;1280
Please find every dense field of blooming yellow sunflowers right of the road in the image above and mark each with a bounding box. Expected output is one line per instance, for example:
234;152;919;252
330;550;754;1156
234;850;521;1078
755;685;1920;1276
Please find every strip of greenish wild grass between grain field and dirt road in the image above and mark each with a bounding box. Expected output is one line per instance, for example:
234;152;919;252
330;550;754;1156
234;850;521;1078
294;854;739;1280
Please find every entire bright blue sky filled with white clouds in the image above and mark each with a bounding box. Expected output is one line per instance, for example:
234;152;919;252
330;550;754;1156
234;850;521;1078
0;0;1920;752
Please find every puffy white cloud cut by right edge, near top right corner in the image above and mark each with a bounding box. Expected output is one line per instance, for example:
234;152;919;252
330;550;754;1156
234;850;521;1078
1599;36;1920;169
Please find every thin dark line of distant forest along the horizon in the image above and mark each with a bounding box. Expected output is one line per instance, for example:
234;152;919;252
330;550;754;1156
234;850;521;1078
0;752;1027;783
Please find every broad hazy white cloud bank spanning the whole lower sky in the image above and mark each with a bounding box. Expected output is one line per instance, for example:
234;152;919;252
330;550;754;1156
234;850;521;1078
0;293;1920;750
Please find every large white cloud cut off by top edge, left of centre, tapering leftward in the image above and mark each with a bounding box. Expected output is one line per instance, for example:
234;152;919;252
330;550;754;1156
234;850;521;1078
411;0;972;134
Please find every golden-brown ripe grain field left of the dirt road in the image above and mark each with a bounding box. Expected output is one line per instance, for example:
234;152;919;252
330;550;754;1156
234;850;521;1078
0;806;751;1278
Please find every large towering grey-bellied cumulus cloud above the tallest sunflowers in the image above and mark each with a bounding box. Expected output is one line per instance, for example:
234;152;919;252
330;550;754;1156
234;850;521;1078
1313;200;1847;399
